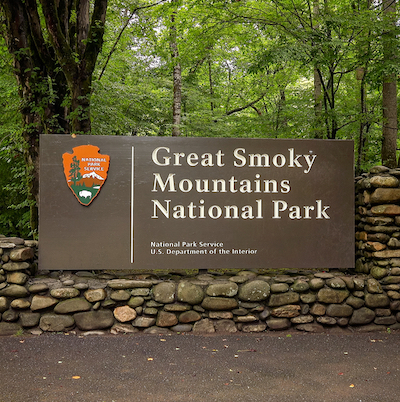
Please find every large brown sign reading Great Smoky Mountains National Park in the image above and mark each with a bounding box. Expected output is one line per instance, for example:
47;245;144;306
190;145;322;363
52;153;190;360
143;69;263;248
39;135;354;270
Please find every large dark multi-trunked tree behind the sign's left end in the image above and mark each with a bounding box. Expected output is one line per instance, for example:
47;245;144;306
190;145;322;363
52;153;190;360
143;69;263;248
0;0;107;234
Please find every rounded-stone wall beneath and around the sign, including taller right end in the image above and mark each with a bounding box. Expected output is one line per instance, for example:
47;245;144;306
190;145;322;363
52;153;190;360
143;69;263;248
0;196;400;335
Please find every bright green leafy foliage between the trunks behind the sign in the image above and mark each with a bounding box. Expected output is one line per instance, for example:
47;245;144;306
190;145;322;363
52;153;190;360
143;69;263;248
0;0;400;233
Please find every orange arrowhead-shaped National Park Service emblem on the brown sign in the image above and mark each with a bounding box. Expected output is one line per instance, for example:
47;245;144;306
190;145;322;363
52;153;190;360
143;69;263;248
62;145;110;206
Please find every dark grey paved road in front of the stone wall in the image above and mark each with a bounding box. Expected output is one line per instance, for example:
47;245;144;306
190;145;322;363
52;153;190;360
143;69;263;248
0;332;400;402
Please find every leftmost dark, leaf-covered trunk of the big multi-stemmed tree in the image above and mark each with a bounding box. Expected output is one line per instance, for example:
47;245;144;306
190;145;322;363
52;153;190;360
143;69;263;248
0;0;65;235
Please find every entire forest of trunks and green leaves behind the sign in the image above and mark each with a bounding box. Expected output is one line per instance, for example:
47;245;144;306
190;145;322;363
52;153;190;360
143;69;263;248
0;0;400;238
